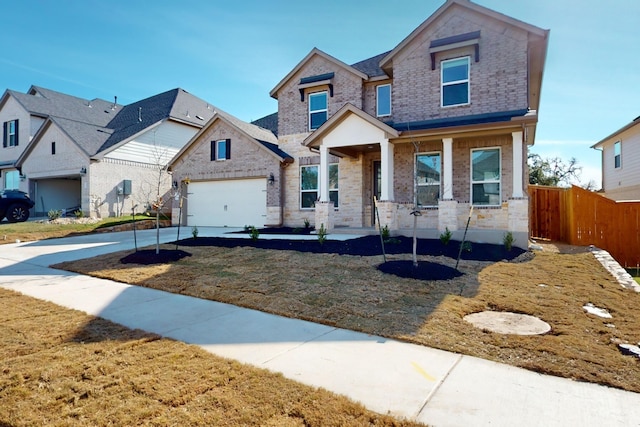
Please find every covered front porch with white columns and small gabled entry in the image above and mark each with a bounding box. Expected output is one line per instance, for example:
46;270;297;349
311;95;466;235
305;105;528;247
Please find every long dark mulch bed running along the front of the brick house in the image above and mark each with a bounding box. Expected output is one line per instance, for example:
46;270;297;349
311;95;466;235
179;236;525;262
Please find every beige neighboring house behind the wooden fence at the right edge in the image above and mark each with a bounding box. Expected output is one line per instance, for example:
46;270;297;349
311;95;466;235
591;117;640;201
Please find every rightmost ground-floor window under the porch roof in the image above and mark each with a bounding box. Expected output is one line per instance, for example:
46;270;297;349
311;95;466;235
471;148;502;206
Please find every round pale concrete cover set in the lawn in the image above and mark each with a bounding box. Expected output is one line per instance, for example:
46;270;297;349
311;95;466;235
464;311;551;335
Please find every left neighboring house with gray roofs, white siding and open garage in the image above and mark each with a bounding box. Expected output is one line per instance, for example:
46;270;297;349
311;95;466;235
0;87;215;217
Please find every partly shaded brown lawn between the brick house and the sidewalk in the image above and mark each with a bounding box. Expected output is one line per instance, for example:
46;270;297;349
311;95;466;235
52;246;640;392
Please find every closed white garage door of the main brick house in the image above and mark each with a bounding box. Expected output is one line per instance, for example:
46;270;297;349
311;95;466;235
187;178;267;227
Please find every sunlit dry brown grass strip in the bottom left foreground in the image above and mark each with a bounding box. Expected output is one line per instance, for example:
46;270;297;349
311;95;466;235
0;289;430;426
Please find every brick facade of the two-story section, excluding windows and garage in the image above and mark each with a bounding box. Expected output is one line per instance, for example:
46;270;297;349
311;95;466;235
272;0;544;249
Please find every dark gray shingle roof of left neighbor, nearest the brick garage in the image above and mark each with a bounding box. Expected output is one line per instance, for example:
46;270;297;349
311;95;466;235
96;88;216;154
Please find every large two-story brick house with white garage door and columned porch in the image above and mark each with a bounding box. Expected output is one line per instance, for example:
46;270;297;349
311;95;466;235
171;0;549;247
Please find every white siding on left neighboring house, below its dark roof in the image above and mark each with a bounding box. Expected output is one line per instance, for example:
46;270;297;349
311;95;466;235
105;121;198;164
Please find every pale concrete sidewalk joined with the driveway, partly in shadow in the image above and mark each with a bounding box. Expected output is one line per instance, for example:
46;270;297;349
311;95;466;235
0;231;640;426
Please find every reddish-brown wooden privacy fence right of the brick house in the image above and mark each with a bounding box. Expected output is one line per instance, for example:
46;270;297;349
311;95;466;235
529;185;640;267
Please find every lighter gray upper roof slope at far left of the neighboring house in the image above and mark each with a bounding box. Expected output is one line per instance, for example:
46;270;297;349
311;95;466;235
7;86;122;126
